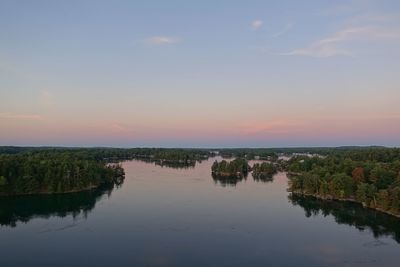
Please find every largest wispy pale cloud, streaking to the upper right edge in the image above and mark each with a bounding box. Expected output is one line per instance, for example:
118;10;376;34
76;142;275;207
280;26;400;57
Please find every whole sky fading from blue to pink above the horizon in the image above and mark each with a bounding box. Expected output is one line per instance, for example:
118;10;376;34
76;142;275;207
0;0;400;147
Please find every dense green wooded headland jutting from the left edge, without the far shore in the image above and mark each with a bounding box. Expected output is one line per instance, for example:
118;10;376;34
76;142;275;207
0;150;124;195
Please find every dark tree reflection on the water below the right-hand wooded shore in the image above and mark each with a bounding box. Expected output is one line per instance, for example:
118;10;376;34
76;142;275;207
288;194;400;243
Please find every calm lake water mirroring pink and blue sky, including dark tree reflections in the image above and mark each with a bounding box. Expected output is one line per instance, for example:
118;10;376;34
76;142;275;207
0;159;400;266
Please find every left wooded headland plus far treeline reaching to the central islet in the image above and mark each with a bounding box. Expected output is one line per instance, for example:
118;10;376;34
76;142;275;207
0;147;210;196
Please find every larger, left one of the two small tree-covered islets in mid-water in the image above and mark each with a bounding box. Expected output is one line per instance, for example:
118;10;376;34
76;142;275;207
211;158;251;177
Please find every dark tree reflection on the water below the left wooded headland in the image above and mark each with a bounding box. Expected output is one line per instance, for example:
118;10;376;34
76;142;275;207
0;185;118;227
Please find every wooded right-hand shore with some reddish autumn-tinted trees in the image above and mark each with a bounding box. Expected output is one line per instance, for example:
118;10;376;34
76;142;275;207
287;148;400;218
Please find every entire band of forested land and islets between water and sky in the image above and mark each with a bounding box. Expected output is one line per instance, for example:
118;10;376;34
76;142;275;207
0;147;400;220
